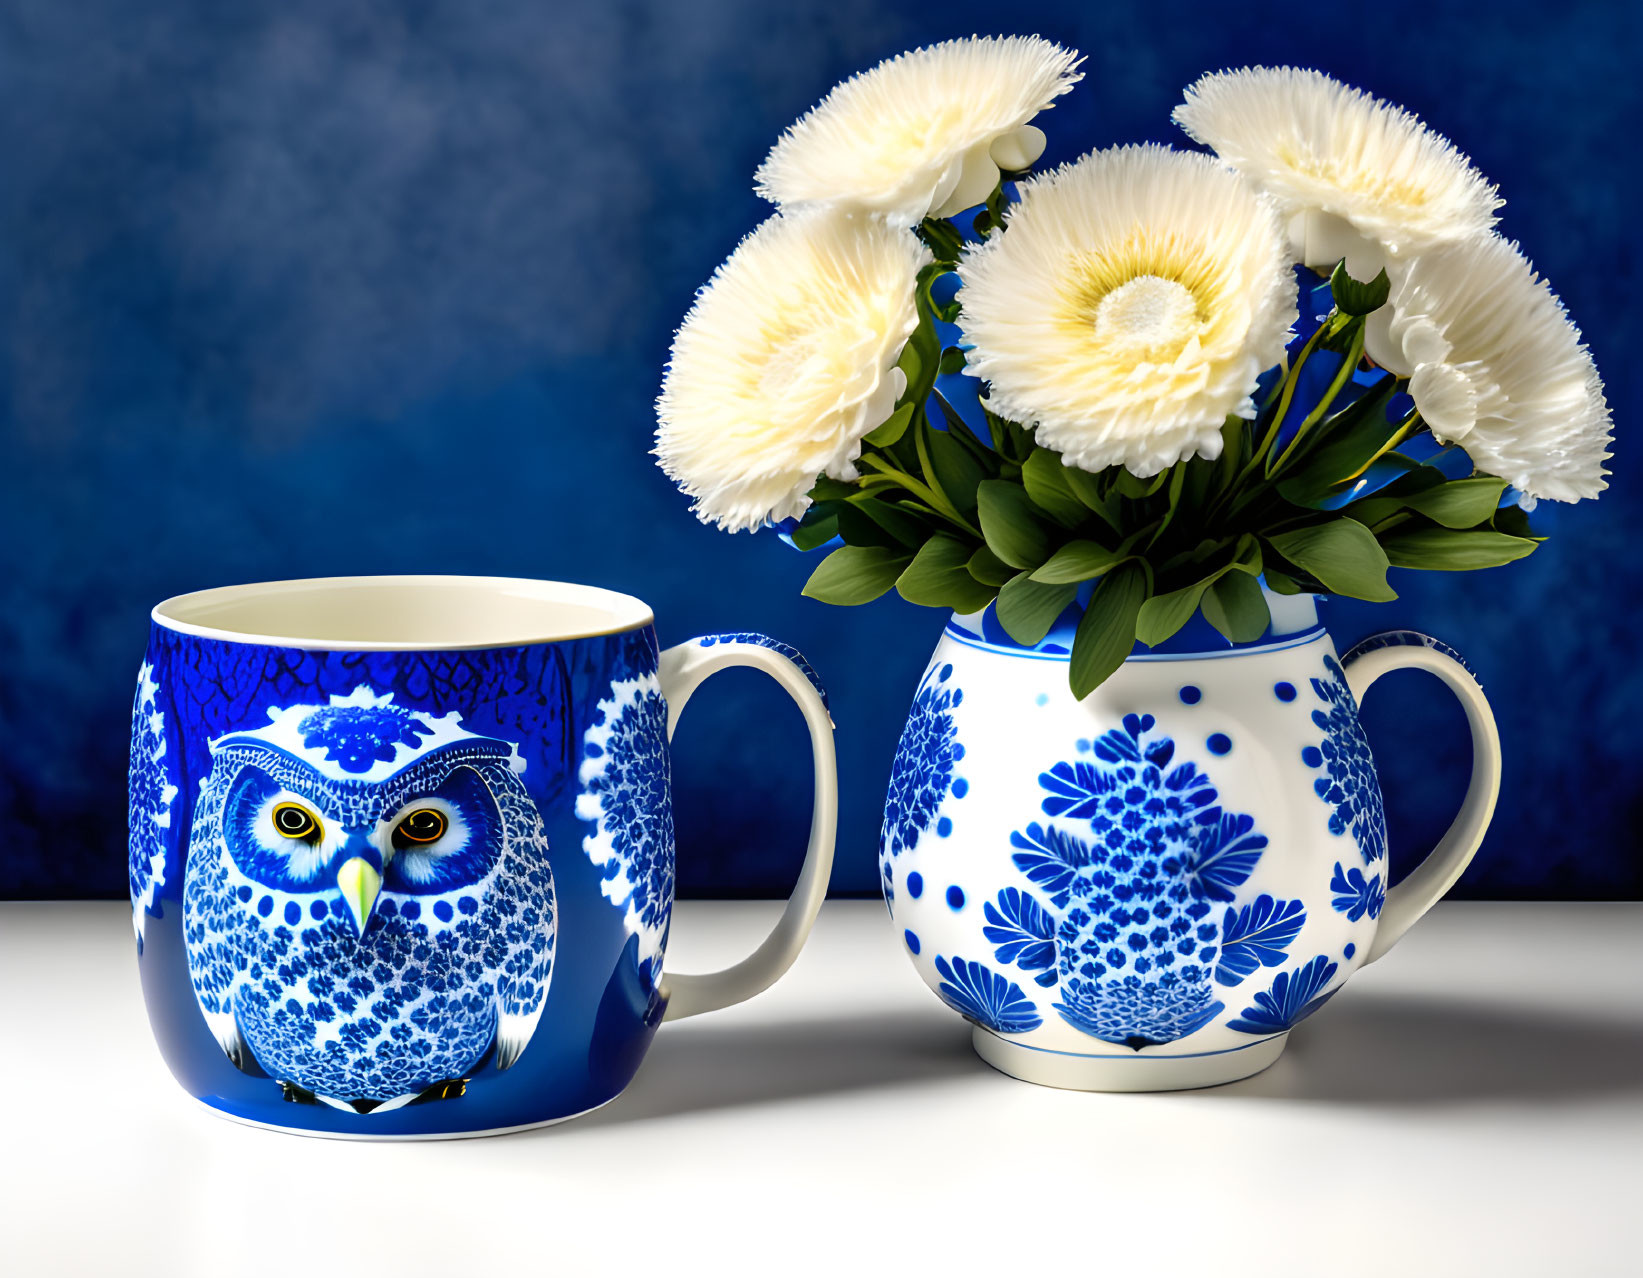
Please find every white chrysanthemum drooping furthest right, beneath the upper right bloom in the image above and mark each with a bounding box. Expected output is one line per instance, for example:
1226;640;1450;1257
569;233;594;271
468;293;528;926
1364;235;1613;501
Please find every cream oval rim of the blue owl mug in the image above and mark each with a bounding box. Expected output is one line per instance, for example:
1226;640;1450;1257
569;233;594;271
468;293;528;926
150;573;656;652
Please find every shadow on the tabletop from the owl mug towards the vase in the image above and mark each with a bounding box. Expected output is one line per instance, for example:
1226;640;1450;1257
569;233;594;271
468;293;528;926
575;1014;987;1130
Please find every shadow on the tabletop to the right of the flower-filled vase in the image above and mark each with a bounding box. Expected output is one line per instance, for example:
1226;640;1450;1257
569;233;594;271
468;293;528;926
1203;992;1643;1106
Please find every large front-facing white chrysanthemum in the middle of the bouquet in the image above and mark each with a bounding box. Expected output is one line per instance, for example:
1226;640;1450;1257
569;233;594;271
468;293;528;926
958;146;1295;476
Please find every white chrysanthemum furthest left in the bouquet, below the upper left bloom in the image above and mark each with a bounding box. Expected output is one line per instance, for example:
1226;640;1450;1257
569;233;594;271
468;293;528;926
654;210;930;532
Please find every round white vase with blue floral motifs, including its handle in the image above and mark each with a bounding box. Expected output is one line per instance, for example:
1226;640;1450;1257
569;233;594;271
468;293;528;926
879;593;1500;1091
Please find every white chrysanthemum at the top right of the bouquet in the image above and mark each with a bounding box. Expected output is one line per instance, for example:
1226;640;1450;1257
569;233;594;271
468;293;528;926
1175;67;1502;279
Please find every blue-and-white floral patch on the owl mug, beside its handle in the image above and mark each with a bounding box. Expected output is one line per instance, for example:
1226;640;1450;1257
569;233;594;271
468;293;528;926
577;673;674;987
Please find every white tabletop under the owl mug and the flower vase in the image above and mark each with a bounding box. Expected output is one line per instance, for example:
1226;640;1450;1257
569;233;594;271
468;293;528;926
0;902;1643;1278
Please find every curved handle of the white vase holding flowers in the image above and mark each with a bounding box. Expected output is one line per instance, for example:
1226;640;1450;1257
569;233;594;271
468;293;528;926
1341;631;1500;964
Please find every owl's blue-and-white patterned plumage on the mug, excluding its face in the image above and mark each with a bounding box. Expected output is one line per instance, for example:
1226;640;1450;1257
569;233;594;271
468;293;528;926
184;722;555;1101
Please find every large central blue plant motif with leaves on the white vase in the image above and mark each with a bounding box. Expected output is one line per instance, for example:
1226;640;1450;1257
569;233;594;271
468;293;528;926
984;715;1281;1051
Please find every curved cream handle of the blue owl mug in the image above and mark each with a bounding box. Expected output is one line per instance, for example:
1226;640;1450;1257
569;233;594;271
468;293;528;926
657;634;838;1020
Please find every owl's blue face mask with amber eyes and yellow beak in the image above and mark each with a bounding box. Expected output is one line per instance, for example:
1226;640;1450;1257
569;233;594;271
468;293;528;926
223;751;503;936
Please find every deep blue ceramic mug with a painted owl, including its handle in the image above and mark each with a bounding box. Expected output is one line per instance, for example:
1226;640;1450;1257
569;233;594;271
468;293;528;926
130;577;838;1138
